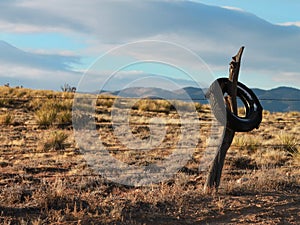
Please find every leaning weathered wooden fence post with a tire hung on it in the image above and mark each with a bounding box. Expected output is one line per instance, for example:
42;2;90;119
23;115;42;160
204;47;244;193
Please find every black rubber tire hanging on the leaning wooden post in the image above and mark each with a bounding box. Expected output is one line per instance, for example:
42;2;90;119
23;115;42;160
206;78;263;132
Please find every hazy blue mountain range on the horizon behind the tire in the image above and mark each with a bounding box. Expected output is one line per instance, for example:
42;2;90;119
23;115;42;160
112;87;300;112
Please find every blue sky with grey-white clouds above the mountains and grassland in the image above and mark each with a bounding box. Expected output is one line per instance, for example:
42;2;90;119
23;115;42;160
0;0;300;90
